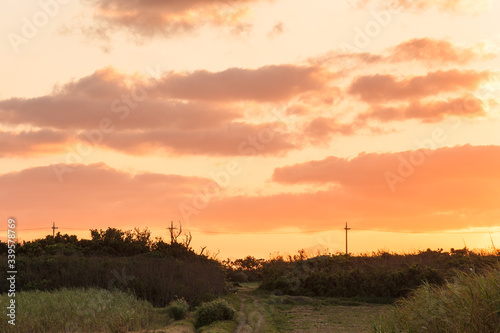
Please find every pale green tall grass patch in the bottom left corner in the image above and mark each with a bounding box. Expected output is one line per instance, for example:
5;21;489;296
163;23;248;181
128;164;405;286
0;289;153;333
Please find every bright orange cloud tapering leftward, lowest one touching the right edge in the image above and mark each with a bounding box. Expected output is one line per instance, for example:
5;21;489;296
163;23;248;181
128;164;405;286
273;144;500;189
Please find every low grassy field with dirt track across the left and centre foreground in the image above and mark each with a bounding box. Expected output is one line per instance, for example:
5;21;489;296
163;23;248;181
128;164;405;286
0;283;389;333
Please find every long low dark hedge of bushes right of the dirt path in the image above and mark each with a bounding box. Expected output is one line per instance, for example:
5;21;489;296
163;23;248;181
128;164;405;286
261;248;500;301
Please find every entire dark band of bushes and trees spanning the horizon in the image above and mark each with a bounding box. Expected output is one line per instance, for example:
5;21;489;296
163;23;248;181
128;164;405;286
0;228;500;307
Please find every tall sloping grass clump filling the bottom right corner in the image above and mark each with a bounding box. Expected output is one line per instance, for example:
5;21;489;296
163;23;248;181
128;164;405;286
374;269;500;333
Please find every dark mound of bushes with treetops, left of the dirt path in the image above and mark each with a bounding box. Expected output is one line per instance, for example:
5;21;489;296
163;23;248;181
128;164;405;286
0;228;225;307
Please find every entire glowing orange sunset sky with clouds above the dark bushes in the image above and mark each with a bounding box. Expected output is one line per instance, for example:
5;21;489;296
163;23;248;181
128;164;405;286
0;0;500;259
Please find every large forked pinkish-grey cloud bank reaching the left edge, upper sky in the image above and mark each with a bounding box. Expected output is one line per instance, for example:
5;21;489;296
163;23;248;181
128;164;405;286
0;65;308;156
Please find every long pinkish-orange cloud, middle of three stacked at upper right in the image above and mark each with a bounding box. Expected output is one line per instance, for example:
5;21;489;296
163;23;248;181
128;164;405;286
349;69;493;103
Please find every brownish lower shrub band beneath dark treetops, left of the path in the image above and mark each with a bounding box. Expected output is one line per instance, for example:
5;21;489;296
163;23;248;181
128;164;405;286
0;254;225;307
